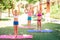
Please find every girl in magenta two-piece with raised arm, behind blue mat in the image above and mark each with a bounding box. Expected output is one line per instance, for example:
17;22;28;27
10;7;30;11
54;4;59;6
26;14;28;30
37;4;42;30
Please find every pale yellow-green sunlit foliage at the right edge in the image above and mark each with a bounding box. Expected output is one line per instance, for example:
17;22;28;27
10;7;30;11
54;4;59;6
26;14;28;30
51;5;60;19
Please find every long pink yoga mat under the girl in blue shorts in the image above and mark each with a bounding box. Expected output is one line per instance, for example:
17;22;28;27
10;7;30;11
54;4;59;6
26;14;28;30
0;35;33;39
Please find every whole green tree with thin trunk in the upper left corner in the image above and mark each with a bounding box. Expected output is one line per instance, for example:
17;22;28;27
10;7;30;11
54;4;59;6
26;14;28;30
0;0;12;16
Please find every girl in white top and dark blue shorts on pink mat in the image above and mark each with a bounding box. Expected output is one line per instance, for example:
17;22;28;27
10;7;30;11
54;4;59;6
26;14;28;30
13;10;19;37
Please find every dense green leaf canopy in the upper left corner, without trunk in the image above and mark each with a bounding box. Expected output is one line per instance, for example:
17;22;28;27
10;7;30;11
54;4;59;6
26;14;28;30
0;0;16;10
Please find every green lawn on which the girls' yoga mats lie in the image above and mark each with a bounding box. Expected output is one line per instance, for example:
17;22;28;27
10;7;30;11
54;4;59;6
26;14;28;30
0;23;60;40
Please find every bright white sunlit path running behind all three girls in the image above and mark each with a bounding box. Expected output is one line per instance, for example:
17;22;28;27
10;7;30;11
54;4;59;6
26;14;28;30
0;14;60;27
